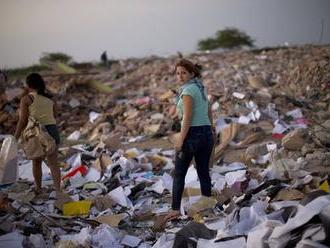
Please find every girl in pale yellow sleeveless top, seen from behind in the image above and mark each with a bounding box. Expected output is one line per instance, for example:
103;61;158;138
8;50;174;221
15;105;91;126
15;73;61;195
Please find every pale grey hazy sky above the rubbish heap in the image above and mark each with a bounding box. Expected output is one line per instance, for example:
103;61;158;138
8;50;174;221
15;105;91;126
0;0;330;68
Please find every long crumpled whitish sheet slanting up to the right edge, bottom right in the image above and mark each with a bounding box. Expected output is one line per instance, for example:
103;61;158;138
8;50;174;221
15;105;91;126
269;195;330;247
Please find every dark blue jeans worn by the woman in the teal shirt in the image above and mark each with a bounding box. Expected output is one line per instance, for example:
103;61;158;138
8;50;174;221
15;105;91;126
172;126;214;210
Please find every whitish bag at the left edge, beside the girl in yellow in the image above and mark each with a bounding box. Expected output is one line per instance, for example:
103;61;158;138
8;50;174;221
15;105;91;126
0;136;18;185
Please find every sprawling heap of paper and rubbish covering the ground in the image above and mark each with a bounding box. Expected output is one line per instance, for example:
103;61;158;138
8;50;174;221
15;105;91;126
0;46;330;248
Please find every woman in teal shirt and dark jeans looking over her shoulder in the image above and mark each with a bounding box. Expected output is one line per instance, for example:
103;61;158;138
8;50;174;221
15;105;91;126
166;59;214;220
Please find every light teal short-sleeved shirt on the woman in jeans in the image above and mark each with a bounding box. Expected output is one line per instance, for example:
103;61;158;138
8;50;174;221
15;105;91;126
176;83;211;126
